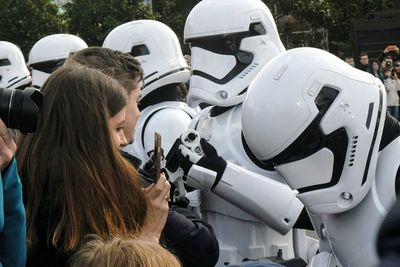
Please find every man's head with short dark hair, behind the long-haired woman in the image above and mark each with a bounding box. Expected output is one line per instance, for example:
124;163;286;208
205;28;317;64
66;47;143;146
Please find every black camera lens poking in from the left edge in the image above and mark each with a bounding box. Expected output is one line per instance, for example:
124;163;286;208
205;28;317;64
0;87;43;133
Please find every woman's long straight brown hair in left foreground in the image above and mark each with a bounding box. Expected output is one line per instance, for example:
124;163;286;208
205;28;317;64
17;66;147;252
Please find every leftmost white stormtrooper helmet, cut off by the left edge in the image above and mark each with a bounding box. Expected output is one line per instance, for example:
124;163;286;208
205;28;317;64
0;41;31;89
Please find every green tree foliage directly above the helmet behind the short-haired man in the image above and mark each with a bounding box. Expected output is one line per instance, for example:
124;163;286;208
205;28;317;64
65;0;154;46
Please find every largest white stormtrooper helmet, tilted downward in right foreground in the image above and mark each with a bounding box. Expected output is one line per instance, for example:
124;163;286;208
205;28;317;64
242;48;386;213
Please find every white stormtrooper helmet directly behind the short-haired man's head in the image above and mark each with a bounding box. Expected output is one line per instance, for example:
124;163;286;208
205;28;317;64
103;20;190;99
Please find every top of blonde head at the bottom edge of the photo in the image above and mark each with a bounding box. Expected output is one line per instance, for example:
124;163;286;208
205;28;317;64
70;235;181;267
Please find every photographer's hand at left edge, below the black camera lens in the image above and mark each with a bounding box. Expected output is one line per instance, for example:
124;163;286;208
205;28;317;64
0;119;17;172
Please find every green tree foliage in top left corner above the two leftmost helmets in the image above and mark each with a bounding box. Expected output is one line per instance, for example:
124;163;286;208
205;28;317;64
0;0;66;57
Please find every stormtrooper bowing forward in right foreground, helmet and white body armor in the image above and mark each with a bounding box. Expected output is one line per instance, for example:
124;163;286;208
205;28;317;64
242;48;400;267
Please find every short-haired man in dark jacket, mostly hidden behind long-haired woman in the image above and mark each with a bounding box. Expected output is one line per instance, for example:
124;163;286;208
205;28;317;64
66;47;219;267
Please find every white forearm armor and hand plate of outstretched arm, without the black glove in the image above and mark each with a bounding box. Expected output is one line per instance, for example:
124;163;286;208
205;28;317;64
187;162;303;234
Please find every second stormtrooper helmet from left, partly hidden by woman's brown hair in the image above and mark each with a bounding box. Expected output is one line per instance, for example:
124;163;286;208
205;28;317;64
28;33;88;88
